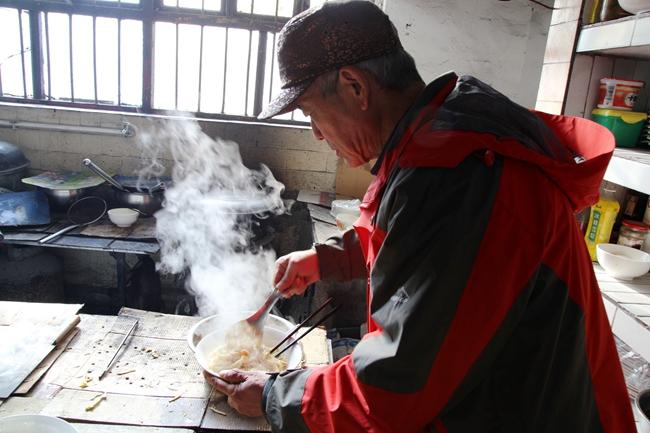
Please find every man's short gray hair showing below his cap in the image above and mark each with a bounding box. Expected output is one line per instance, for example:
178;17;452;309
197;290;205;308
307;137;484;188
316;48;423;96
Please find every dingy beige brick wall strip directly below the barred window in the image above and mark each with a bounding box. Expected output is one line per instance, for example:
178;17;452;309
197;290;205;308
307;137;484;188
0;105;337;191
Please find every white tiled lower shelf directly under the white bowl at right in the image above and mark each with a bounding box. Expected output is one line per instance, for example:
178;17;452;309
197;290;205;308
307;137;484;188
594;263;650;360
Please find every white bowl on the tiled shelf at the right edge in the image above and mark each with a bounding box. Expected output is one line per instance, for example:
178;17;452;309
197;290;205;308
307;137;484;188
596;244;650;280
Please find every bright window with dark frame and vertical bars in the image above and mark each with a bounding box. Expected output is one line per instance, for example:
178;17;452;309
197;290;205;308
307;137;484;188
0;0;334;123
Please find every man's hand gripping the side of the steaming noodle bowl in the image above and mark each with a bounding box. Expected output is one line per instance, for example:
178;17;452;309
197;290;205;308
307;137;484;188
203;370;269;417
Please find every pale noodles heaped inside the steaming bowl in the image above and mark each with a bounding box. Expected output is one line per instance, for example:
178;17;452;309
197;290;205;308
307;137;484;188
208;322;287;372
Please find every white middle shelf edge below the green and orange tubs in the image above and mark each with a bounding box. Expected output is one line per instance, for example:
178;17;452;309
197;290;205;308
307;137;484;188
605;147;650;194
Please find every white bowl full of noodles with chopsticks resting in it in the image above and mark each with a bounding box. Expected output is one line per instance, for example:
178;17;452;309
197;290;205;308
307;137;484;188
194;318;303;375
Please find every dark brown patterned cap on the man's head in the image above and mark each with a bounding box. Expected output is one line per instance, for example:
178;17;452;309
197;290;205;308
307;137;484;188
258;0;401;119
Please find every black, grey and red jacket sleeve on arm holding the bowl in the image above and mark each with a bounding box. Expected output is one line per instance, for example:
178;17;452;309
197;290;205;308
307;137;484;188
266;158;516;433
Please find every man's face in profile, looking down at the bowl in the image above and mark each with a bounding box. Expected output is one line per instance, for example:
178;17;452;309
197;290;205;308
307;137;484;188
298;72;376;167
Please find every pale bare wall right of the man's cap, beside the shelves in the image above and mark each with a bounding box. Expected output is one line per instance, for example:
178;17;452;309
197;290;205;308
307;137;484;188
383;0;553;107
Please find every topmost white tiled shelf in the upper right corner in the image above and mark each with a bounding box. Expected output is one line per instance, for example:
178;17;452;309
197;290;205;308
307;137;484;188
576;12;650;59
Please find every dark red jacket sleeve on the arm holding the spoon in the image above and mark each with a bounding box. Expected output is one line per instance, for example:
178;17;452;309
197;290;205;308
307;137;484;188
315;229;368;281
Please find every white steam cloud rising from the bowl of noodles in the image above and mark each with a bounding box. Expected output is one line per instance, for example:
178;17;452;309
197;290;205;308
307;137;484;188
141;121;284;317
